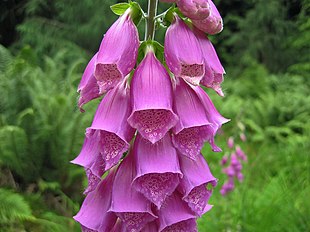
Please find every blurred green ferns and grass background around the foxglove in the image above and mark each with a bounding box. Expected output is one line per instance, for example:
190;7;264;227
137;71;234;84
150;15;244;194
0;0;310;232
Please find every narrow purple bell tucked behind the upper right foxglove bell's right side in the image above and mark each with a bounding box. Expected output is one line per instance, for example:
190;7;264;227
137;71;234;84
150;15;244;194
195;29;225;97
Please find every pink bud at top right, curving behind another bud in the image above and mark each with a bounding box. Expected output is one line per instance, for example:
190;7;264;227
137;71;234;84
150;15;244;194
192;0;223;35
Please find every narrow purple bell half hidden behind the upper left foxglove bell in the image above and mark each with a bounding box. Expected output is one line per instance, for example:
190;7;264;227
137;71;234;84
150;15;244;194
77;53;102;112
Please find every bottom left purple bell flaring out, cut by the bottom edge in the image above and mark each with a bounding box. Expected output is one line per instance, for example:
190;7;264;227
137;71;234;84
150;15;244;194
73;170;117;232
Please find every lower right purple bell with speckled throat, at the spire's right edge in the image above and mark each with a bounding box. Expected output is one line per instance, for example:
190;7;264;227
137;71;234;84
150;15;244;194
178;154;217;217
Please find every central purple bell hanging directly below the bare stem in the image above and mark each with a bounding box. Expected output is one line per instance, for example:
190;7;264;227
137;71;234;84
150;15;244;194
128;51;178;143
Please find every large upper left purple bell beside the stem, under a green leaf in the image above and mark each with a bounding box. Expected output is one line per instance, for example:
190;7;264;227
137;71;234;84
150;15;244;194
95;8;139;92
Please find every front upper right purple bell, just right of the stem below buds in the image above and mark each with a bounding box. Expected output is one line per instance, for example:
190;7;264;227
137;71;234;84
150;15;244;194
165;15;205;85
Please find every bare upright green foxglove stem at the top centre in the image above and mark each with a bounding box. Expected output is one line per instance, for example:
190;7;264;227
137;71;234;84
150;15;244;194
144;0;158;40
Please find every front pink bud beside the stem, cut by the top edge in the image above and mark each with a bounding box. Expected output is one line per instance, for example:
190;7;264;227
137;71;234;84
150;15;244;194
177;0;210;20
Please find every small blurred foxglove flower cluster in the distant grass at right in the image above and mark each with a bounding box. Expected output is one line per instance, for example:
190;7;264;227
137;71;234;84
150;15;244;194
220;133;248;195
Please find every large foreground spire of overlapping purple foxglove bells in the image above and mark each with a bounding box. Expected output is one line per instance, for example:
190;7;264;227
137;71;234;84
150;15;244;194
72;1;229;232
